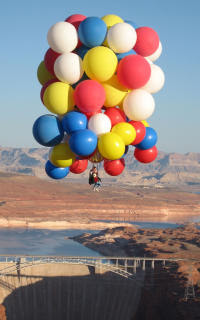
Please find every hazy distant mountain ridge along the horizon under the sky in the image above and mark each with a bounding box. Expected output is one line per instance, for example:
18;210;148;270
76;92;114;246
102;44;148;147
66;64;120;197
0;147;200;187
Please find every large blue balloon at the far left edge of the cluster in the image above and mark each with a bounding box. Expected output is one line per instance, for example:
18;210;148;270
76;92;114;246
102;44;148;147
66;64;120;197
32;114;64;147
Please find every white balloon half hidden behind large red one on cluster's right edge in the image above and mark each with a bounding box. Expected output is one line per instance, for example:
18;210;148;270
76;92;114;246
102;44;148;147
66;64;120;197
140;64;165;93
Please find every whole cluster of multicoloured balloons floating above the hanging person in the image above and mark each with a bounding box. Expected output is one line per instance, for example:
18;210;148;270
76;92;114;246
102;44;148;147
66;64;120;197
33;14;165;179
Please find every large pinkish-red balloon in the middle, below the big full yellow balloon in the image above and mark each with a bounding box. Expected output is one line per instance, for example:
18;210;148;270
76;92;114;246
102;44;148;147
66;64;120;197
74;80;106;113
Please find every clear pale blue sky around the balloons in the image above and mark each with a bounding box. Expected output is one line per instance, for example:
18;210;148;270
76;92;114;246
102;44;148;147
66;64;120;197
0;0;200;153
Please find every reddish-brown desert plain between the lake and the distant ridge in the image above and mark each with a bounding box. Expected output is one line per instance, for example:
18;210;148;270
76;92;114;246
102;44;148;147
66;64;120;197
0;172;200;230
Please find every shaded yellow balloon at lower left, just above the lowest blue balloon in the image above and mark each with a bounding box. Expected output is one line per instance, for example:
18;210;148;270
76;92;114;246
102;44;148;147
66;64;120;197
49;142;76;168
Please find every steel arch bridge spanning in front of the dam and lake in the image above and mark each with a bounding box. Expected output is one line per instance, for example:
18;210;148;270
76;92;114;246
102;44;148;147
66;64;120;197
0;255;194;279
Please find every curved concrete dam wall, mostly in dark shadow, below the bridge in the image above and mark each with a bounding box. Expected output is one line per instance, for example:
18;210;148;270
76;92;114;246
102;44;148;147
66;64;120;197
0;263;141;320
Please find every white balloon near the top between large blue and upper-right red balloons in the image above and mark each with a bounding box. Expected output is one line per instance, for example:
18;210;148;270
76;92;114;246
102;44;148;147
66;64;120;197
107;22;137;53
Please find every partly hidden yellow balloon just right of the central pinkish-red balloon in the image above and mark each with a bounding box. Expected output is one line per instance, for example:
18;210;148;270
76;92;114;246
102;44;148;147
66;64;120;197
102;75;128;107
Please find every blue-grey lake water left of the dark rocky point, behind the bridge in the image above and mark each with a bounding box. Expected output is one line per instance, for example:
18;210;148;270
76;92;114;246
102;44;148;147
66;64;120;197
0;229;99;256
